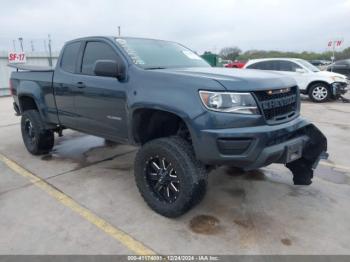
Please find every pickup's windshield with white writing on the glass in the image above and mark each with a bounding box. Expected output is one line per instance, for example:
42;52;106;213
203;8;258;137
116;38;210;69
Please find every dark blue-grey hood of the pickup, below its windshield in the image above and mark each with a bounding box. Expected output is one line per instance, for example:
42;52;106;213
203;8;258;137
163;67;296;91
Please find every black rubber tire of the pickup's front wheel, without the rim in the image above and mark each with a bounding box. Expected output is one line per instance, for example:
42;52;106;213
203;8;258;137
135;136;207;218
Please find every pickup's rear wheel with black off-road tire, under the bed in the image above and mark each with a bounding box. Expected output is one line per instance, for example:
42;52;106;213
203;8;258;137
21;110;55;155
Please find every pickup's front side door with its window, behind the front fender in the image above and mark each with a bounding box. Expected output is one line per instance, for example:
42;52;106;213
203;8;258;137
75;40;127;140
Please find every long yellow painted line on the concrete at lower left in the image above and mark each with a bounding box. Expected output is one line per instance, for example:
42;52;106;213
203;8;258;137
0;154;156;255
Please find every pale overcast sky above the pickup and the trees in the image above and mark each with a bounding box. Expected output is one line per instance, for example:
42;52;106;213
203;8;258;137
0;0;350;53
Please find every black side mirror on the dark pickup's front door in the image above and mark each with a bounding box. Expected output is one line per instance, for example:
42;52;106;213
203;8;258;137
94;60;125;80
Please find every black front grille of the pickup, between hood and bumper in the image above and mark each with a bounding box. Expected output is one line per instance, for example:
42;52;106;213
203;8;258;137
254;86;299;122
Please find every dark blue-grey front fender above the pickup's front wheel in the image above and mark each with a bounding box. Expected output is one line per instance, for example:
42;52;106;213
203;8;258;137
126;67;225;145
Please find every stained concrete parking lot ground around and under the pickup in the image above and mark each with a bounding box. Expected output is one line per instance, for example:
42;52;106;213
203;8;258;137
0;97;350;255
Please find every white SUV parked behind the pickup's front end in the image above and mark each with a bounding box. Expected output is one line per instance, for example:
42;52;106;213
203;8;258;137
243;58;349;102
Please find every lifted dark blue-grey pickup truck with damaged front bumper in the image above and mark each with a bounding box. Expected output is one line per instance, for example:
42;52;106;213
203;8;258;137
10;37;327;217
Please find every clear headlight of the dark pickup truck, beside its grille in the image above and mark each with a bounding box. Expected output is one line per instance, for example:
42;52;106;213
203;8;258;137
199;91;259;114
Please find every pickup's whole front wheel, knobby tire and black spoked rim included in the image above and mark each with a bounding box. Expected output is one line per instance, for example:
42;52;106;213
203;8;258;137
135;137;207;217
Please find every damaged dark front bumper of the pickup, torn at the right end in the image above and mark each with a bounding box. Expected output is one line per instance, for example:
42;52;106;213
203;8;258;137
194;117;327;170
